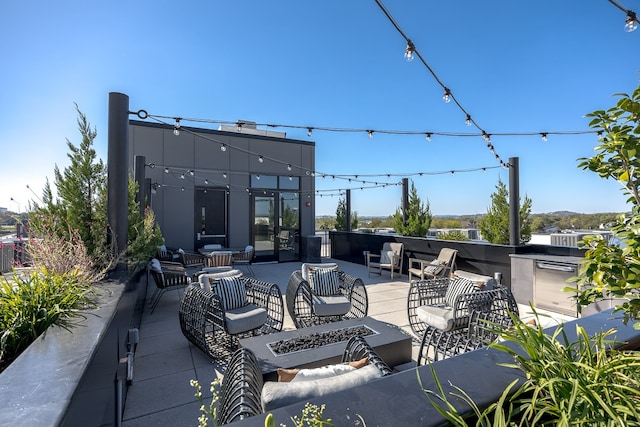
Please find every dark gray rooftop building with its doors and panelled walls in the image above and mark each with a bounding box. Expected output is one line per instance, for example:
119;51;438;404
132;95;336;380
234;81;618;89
128;120;315;261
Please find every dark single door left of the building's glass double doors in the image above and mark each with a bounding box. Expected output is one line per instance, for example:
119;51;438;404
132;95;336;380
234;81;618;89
194;188;228;249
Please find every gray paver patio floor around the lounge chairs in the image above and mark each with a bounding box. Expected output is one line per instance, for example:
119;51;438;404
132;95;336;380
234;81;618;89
122;259;558;427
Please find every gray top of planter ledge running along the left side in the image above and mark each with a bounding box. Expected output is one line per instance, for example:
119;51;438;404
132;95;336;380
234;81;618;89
0;283;125;427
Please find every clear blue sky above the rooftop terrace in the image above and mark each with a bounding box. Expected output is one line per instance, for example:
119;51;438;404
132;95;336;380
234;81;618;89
0;0;640;216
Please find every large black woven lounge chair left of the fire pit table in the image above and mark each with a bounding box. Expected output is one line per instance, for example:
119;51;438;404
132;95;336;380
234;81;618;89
179;270;284;358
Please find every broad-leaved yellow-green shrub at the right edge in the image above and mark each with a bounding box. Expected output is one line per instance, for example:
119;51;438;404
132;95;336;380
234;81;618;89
573;87;640;329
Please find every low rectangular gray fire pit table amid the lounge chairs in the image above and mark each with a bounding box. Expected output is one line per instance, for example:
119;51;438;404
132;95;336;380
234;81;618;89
240;317;411;380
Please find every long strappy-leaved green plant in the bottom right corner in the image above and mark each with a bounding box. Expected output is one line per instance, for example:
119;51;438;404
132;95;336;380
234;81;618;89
425;310;640;426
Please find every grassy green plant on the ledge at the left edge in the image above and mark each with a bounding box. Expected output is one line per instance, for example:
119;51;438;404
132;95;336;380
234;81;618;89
0;268;94;369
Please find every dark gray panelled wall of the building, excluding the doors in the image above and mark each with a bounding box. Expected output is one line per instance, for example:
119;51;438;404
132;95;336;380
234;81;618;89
129;121;315;254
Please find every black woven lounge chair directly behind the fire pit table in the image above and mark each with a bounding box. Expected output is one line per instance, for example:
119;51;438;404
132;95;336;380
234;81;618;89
287;263;369;328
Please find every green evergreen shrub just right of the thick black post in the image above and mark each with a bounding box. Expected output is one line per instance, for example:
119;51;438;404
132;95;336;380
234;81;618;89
127;176;164;270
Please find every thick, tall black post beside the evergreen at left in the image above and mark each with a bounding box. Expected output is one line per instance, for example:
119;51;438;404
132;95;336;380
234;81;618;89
107;92;129;269
